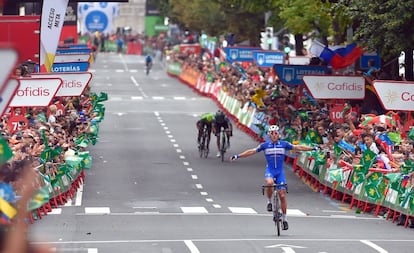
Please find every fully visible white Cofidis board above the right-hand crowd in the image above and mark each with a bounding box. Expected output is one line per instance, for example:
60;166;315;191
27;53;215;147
303;75;365;99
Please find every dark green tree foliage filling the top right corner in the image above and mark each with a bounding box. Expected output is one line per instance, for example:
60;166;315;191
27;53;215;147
339;0;414;80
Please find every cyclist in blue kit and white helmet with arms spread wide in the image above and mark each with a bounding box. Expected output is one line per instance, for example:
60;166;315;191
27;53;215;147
230;125;317;230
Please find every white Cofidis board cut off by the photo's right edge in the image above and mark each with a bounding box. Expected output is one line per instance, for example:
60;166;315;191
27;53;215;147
373;81;414;111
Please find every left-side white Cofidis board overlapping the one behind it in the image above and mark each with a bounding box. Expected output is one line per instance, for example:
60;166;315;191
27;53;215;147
9;78;62;107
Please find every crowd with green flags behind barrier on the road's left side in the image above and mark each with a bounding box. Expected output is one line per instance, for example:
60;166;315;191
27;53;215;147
0;62;108;251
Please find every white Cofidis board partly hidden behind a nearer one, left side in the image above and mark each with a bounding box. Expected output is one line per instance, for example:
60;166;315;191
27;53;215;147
32;72;92;97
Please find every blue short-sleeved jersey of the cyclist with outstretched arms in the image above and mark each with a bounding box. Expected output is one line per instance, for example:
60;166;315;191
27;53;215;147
256;141;293;172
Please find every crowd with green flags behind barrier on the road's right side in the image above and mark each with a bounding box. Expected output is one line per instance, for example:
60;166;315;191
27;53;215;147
167;46;414;227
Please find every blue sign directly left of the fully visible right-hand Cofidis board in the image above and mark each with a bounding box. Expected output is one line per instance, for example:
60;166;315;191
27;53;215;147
274;65;328;85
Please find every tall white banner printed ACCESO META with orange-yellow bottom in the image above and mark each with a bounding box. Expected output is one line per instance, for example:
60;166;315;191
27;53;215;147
40;0;69;72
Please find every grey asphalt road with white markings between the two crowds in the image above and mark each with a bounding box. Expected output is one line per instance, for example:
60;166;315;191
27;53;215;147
31;54;414;253
